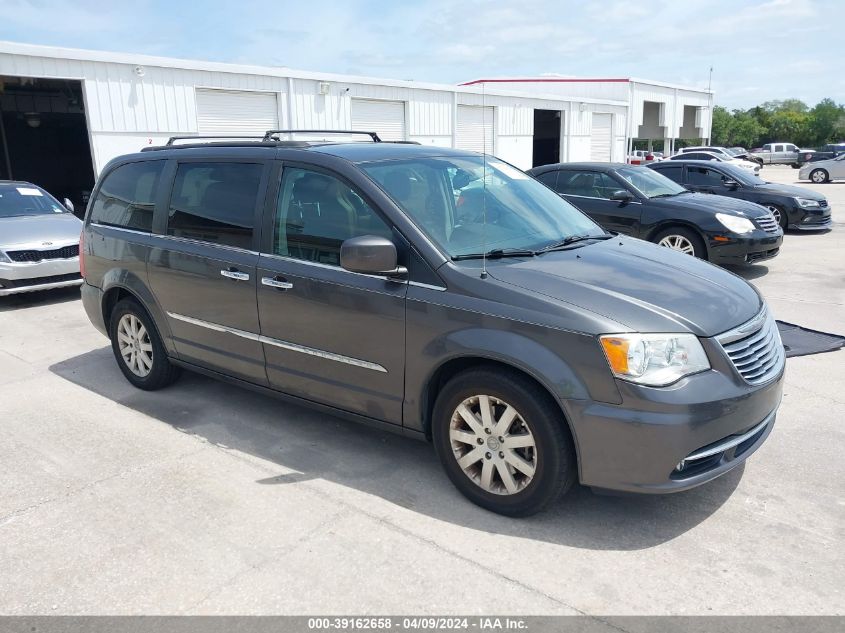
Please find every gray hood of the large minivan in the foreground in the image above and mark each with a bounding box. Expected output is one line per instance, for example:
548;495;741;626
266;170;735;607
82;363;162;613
488;236;762;337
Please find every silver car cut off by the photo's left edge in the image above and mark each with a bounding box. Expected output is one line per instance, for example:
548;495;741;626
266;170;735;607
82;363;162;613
0;180;82;297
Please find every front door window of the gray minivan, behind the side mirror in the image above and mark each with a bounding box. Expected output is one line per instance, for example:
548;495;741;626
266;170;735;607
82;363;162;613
273;168;391;266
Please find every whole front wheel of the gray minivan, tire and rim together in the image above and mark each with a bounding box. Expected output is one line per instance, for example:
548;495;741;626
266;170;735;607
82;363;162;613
432;368;575;517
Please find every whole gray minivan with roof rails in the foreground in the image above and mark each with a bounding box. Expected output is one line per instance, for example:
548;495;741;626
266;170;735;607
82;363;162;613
81;133;784;516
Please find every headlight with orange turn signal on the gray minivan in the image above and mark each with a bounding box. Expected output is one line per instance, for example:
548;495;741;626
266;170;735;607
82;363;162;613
599;334;710;387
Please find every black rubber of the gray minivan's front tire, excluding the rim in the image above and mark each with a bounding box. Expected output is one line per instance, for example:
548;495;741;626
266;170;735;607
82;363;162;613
432;367;576;517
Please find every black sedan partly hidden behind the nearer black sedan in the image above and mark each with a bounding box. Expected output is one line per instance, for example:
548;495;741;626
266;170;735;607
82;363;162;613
649;160;831;231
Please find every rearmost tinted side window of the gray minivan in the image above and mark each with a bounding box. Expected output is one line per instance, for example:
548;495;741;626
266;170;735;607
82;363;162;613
91;160;164;231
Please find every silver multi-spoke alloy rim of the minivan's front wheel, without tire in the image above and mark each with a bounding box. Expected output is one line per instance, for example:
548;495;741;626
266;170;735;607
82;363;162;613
449;395;538;495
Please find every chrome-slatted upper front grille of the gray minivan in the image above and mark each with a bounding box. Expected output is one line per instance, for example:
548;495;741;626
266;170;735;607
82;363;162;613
717;306;786;385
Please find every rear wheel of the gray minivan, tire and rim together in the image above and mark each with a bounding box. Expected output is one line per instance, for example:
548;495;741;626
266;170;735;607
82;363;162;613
109;299;179;391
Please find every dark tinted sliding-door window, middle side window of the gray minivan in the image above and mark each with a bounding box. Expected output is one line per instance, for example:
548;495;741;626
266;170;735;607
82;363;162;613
167;163;263;249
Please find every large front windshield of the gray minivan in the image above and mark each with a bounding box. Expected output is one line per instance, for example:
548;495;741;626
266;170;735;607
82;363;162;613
361;156;605;258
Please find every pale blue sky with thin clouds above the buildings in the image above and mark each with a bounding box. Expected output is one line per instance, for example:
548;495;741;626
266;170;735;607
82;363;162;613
0;0;845;108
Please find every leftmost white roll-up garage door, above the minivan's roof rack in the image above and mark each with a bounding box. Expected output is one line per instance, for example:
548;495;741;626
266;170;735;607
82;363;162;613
197;88;279;136
